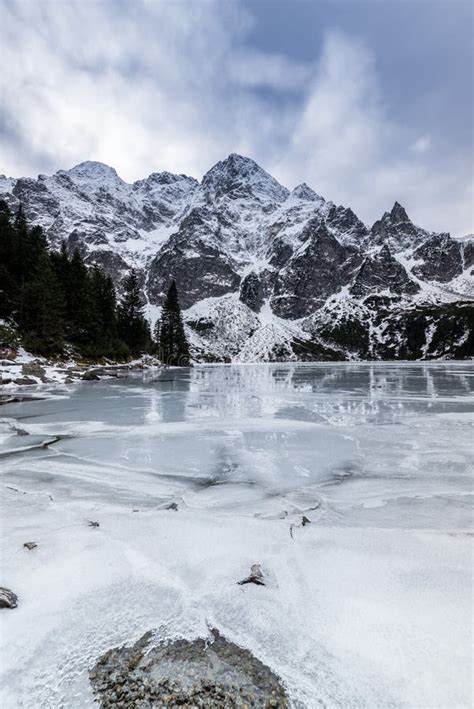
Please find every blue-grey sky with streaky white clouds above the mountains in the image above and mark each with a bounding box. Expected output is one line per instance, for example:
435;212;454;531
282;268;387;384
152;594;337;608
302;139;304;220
0;0;474;235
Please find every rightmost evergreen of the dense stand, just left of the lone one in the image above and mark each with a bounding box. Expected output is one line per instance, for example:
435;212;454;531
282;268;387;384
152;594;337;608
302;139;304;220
117;269;151;355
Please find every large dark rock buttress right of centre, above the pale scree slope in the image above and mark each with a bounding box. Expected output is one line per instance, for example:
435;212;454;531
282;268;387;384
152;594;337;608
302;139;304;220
271;218;359;318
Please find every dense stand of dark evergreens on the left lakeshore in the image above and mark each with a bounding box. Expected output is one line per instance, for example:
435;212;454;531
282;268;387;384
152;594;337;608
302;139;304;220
0;200;144;359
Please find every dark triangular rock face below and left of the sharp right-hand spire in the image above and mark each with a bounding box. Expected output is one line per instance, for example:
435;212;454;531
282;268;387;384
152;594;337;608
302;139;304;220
350;246;420;296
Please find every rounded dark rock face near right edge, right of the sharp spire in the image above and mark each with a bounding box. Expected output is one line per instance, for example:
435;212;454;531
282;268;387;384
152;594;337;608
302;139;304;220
413;234;463;283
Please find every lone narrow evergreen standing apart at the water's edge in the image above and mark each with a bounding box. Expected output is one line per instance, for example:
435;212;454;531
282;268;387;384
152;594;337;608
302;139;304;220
158;281;190;367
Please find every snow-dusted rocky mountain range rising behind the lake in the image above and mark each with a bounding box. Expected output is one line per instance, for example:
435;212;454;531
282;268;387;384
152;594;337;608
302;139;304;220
0;154;474;361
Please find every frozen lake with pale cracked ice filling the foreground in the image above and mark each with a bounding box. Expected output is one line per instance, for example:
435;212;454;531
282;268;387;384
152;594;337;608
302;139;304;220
0;363;474;709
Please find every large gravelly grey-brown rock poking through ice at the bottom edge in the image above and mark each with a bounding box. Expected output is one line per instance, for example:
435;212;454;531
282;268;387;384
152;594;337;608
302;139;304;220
89;630;289;709
